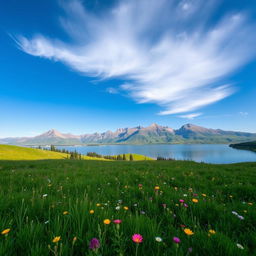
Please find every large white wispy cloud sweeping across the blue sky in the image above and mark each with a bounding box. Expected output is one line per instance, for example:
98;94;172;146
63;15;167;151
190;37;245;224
16;0;256;115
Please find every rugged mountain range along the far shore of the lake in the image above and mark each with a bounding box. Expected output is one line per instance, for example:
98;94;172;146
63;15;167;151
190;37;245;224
0;123;256;146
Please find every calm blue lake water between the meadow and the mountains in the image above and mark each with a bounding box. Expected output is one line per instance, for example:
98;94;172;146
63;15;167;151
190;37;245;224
58;144;256;164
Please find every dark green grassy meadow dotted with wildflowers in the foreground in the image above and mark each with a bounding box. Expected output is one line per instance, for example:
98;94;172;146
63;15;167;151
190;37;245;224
0;160;256;256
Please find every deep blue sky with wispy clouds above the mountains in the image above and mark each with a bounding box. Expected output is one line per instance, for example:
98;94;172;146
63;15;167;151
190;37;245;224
0;0;256;137
